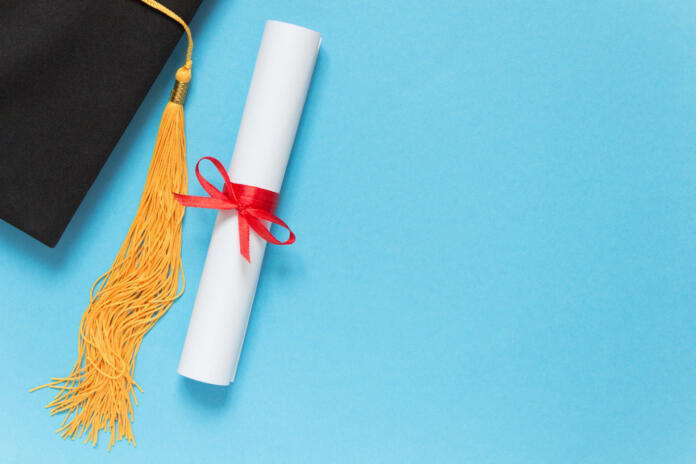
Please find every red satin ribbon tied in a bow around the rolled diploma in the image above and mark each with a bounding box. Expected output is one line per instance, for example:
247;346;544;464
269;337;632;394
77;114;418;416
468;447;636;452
174;156;295;262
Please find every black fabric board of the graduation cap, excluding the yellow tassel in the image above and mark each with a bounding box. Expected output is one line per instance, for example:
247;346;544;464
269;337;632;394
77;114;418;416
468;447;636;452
0;0;200;246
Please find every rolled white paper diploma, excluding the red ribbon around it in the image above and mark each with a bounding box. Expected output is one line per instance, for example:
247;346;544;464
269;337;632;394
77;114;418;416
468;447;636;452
179;21;321;385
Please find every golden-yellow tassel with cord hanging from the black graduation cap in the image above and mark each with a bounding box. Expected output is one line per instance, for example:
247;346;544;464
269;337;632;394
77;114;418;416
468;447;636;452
32;0;193;449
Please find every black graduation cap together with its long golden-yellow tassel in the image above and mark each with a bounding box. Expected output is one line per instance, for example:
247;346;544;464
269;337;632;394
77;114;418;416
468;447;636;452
7;0;200;448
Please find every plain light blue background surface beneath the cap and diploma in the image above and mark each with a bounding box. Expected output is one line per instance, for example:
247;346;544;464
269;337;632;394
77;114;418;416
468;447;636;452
0;0;696;463
